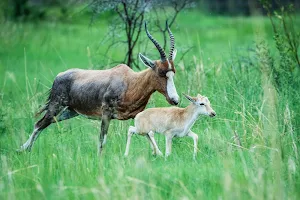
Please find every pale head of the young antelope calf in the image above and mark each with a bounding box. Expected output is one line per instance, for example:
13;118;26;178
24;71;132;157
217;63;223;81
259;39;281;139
183;94;217;117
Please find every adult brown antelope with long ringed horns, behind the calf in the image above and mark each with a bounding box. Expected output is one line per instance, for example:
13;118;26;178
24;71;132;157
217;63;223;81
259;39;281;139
19;22;179;154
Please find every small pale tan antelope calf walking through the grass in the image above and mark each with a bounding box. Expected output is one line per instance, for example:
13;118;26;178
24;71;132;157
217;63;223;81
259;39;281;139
124;94;216;159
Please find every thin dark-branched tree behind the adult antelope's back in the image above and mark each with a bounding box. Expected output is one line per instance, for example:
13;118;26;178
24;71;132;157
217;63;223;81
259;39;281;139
90;0;193;68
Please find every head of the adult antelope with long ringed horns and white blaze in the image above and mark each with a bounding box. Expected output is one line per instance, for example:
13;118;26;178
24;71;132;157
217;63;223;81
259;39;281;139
139;22;179;105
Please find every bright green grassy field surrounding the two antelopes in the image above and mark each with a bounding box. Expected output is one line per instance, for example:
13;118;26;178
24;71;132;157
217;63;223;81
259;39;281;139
0;8;300;199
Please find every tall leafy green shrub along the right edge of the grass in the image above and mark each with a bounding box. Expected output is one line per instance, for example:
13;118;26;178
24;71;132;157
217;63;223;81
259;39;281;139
261;0;300;147
